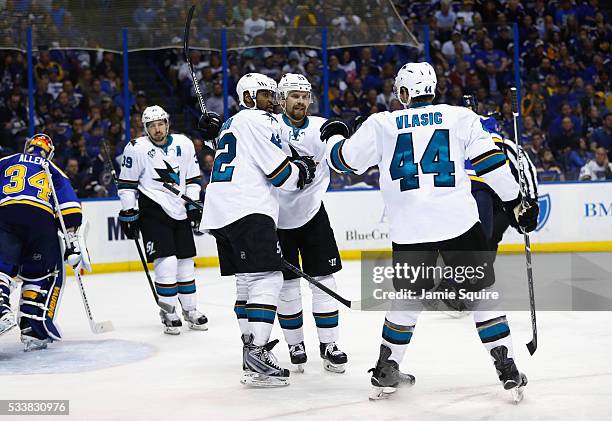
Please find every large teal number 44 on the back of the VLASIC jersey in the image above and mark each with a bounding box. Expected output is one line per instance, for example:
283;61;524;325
389;129;455;191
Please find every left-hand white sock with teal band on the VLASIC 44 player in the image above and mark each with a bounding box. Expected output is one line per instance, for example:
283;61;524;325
382;311;420;364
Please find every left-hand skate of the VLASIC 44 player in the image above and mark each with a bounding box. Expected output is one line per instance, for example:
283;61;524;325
368;345;416;401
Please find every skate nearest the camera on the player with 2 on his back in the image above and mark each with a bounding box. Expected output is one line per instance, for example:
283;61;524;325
240;340;289;387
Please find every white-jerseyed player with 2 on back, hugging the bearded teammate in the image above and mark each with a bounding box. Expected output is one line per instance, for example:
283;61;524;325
203;73;315;386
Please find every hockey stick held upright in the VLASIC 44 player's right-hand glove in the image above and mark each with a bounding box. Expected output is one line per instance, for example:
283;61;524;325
510;88;538;355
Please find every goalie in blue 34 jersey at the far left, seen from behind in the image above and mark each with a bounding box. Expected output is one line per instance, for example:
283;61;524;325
0;134;89;351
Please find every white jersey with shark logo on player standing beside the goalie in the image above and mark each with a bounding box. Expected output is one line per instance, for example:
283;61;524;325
118;134;201;220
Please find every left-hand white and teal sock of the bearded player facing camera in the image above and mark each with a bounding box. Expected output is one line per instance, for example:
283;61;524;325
278;279;304;345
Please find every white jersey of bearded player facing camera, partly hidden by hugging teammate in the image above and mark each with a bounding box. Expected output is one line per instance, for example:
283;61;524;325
276;114;329;229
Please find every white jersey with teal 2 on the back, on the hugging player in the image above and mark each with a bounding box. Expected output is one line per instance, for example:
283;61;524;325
202;109;299;229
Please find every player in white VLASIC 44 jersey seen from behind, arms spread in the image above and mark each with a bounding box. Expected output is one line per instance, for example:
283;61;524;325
321;63;537;400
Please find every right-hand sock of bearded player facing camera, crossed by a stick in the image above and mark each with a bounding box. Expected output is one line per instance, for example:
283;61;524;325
309;275;338;344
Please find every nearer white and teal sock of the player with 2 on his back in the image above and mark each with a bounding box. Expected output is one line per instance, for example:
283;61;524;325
241;271;283;346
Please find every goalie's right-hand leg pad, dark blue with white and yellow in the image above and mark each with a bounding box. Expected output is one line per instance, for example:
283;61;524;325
19;265;66;341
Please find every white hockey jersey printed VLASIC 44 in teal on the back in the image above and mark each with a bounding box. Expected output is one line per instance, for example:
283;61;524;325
327;103;519;244
